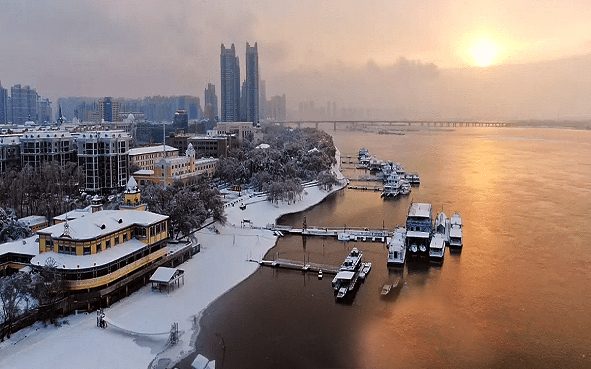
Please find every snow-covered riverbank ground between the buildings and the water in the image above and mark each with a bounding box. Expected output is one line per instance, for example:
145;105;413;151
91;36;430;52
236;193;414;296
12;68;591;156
0;155;341;368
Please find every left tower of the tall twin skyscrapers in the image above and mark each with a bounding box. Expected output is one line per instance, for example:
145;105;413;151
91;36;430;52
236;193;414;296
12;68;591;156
220;44;240;122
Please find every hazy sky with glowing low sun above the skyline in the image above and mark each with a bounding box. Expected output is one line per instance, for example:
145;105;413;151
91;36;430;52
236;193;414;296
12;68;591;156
0;0;591;118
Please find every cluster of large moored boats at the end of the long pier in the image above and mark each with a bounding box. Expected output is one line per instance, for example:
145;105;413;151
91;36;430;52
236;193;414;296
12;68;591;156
387;203;463;266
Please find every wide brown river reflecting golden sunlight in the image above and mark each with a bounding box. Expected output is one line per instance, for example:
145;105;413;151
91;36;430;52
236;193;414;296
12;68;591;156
181;128;591;369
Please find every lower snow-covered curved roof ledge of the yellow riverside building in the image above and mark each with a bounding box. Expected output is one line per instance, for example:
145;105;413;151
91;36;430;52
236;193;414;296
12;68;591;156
31;237;151;269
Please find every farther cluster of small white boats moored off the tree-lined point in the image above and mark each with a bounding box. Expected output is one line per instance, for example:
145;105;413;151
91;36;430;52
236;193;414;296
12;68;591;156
357;149;421;197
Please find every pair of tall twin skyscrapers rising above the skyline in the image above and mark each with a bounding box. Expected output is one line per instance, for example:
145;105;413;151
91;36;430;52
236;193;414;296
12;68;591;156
220;42;260;125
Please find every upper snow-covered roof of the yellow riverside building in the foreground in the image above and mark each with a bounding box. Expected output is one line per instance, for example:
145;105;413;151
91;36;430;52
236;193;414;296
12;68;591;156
37;210;168;240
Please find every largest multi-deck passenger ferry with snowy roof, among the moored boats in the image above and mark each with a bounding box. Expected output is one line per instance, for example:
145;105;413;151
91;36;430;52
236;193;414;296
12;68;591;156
406;202;433;256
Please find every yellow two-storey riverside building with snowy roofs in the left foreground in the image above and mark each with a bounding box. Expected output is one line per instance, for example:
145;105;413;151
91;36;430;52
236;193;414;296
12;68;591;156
31;210;168;291
